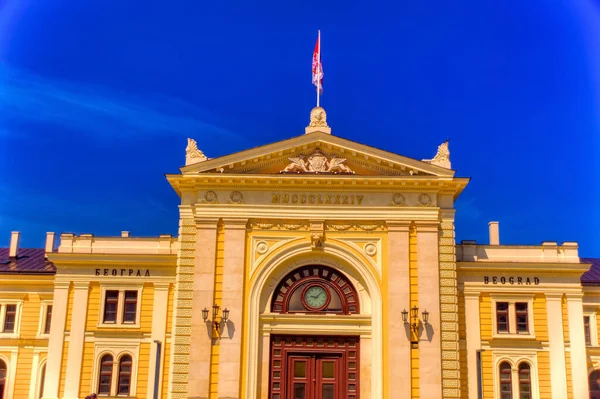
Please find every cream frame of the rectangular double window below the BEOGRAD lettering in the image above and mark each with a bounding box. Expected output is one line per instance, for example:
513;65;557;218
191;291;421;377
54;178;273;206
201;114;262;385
490;294;535;339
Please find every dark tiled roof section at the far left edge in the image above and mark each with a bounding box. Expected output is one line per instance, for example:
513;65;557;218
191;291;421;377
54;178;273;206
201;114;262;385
0;248;56;274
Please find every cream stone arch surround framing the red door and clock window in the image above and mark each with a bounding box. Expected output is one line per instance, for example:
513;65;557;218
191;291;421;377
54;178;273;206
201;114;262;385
244;244;383;399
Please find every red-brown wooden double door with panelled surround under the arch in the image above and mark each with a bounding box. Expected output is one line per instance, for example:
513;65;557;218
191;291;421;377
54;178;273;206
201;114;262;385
269;336;359;399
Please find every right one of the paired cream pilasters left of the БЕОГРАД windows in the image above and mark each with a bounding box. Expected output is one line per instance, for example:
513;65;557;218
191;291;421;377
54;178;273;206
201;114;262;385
64;281;89;399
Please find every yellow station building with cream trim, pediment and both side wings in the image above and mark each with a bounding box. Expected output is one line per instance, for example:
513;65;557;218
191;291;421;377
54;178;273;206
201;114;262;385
0;108;600;399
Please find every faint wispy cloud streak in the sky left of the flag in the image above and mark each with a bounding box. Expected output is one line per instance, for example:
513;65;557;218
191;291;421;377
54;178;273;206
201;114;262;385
0;63;237;139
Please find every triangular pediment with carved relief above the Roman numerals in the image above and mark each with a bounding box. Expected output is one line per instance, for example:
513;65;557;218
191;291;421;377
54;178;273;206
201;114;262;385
181;132;454;177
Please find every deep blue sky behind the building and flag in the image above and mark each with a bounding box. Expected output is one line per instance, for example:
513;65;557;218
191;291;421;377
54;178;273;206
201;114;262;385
0;0;600;257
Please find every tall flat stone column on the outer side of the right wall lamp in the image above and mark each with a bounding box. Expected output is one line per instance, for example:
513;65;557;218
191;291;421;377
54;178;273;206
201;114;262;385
417;221;440;399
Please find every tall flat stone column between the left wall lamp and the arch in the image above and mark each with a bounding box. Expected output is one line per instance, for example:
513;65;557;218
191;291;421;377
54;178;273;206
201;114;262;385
218;219;248;399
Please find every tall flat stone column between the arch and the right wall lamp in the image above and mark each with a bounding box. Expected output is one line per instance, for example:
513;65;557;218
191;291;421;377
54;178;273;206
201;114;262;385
386;221;411;398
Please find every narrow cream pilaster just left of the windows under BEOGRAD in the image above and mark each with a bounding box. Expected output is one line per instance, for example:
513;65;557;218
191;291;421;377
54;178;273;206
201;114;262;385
465;292;481;399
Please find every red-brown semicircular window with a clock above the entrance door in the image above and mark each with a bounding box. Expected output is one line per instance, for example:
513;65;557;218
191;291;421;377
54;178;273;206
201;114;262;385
271;266;359;314
